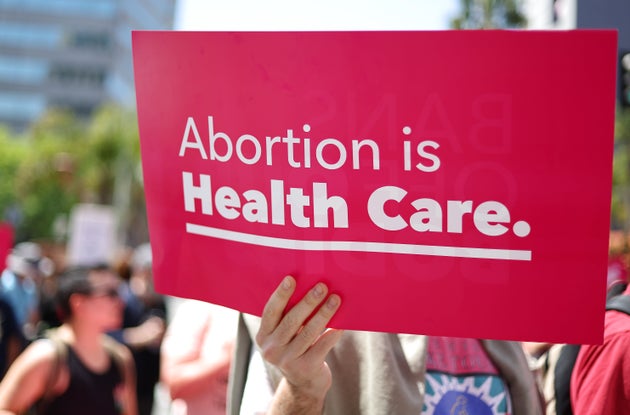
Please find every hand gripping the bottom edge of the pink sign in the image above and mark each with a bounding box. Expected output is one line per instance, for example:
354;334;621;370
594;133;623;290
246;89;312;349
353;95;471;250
256;277;343;414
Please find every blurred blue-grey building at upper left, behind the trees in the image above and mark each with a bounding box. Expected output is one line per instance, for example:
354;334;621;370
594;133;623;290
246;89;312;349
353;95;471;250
0;0;175;131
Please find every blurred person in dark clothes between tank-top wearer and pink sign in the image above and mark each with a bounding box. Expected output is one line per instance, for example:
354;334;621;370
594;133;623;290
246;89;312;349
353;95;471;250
109;244;166;415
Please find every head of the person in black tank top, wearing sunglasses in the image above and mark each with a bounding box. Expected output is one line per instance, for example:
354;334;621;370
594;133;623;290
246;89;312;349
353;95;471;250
57;265;123;330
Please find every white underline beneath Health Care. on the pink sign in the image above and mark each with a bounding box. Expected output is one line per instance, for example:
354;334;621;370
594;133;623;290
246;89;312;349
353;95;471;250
186;223;532;261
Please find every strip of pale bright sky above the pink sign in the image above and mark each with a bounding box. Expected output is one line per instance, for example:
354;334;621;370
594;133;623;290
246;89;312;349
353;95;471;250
175;0;459;31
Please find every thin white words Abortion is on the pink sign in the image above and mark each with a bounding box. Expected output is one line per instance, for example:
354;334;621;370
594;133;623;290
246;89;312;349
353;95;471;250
179;115;440;172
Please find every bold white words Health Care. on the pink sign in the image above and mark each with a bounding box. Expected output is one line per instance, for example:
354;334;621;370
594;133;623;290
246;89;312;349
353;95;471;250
182;172;531;237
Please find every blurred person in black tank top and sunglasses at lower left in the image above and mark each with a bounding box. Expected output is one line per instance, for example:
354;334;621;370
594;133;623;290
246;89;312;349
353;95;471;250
0;266;138;415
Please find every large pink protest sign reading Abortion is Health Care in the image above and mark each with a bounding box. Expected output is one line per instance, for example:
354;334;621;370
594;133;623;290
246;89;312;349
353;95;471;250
133;31;616;343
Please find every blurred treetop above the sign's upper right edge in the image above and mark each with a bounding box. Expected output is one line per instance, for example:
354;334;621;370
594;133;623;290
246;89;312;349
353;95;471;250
451;0;527;29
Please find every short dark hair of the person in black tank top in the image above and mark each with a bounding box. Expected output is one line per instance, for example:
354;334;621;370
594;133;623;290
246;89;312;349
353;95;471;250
56;264;111;321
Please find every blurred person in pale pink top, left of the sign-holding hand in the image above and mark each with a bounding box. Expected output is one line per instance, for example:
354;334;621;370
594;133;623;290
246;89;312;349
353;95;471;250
161;300;238;415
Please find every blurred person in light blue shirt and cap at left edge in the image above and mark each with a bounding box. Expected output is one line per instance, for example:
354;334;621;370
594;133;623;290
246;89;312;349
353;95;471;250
0;242;54;340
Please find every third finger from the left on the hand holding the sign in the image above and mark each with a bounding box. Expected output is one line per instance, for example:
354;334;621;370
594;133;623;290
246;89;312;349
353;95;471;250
290;294;341;358
